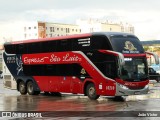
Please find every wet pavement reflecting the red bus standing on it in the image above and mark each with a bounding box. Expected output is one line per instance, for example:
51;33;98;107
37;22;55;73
0;80;160;120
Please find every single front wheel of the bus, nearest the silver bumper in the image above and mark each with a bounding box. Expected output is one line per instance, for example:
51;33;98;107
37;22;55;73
86;83;99;100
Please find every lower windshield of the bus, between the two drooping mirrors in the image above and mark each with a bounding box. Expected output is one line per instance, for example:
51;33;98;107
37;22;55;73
121;58;148;82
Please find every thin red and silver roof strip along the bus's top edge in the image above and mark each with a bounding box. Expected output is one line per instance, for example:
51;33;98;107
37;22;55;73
5;32;134;44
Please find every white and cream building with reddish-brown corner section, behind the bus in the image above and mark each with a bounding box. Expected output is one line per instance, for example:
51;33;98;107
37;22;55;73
24;21;81;39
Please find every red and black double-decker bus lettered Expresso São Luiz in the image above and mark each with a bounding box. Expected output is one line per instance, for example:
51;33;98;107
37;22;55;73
3;32;158;99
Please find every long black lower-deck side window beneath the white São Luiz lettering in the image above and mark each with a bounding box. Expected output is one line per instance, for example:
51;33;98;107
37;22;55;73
23;64;89;76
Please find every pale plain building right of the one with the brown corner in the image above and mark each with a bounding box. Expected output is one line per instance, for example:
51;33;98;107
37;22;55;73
76;19;134;34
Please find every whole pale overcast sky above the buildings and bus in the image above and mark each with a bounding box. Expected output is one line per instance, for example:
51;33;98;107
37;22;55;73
0;0;160;40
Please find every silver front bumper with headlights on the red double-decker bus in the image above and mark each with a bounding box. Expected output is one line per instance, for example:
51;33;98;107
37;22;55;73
115;83;149;96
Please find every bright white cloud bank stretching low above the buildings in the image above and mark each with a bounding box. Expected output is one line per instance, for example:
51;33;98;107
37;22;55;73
1;9;160;40
